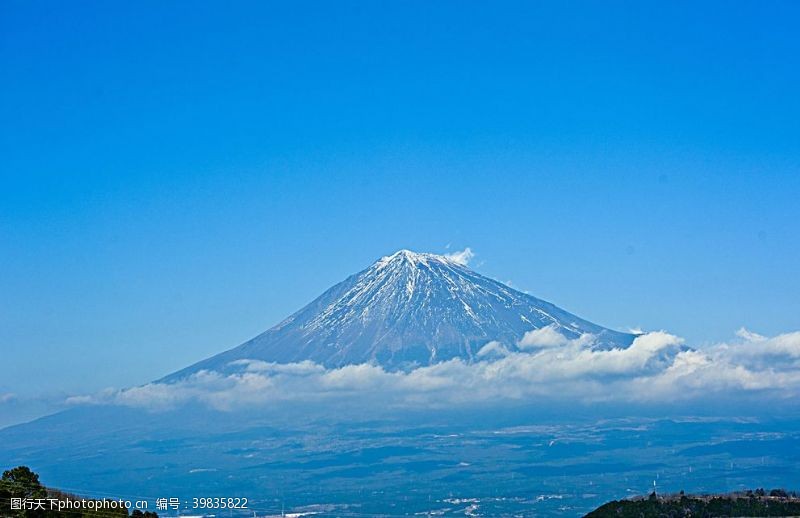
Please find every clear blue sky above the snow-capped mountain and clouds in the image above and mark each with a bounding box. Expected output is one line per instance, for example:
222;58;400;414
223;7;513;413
0;0;800;412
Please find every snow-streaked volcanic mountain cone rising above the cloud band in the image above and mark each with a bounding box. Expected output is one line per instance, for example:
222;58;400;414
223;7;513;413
167;250;635;381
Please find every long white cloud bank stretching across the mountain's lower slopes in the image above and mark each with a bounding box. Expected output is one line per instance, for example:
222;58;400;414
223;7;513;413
69;328;800;410
